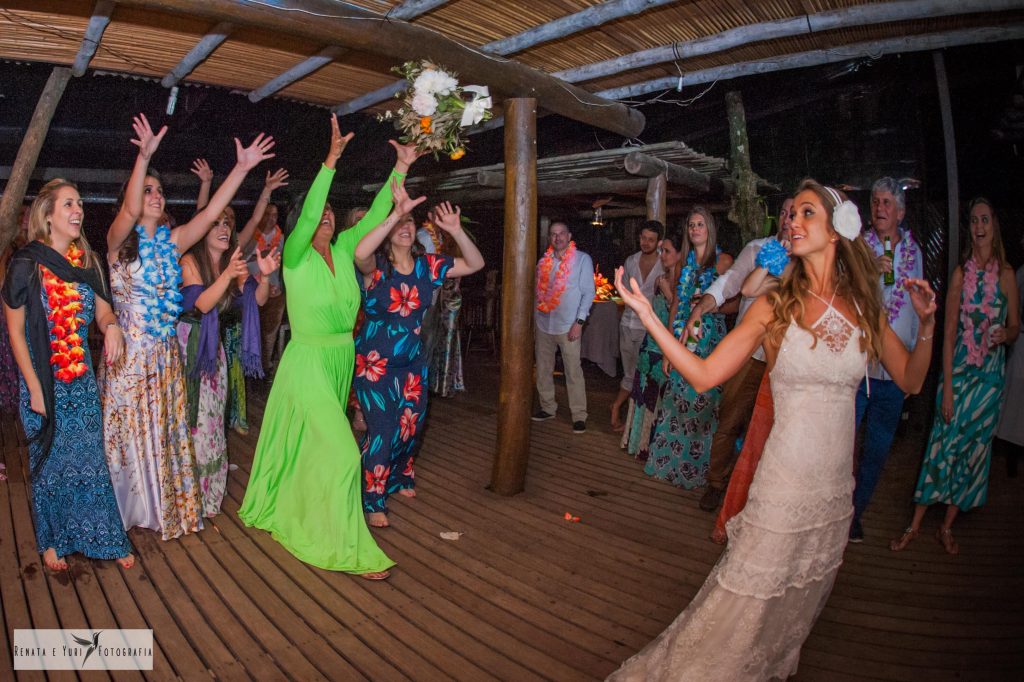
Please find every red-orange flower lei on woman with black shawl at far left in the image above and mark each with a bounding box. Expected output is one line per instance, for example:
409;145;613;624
40;244;88;384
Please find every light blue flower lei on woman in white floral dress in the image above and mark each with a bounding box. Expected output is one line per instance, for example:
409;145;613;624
133;225;181;339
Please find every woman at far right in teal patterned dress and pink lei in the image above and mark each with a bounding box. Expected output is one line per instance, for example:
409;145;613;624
890;199;1020;554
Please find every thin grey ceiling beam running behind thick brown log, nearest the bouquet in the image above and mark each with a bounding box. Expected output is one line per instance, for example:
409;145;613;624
335;0;677;116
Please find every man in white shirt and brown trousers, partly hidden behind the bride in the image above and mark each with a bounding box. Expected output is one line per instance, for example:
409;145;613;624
686;199;793;512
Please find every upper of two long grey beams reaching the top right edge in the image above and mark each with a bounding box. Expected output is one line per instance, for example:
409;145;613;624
553;0;1021;87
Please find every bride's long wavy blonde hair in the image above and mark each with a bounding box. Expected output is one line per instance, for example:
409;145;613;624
767;178;884;360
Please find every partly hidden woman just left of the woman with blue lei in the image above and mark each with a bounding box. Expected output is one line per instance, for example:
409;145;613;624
621;232;684;462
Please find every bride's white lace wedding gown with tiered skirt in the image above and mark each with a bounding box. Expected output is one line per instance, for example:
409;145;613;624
608;305;865;682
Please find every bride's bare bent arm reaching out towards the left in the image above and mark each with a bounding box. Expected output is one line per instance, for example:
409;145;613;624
615;267;772;393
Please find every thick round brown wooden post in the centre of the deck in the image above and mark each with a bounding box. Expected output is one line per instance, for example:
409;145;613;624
490;97;537;496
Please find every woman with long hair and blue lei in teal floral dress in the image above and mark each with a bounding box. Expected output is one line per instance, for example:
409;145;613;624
644;206;732;489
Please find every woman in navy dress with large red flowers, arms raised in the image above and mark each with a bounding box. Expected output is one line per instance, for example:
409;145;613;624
352;196;483;527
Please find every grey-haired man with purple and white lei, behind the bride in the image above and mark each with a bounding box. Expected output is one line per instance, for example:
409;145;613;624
850;177;925;543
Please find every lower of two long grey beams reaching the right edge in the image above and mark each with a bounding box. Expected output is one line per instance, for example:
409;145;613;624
597;24;1024;99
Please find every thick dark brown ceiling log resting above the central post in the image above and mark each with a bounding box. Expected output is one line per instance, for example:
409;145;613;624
120;0;644;137
